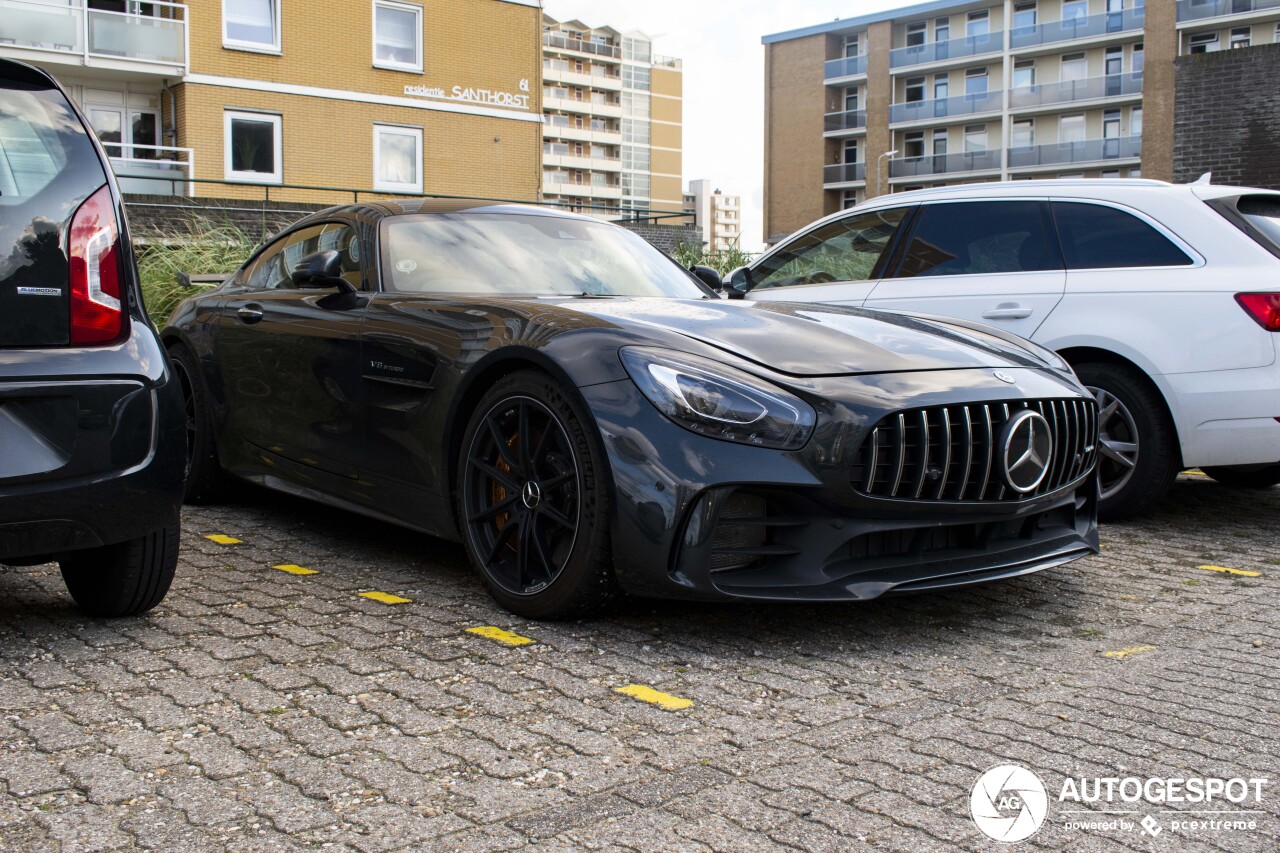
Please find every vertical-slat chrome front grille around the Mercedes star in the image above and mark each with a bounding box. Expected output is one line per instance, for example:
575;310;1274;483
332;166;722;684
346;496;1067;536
850;398;1098;502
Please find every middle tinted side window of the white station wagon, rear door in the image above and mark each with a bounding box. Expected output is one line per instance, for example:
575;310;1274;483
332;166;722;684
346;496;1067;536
895;201;1062;278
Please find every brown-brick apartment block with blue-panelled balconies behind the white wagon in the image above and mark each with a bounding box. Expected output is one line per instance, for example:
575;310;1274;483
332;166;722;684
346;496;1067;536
763;0;1280;238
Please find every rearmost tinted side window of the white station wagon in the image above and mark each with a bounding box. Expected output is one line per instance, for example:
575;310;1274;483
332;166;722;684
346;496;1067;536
1053;201;1196;269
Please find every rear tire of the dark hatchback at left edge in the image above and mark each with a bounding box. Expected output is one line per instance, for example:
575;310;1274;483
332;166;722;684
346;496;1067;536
60;524;179;617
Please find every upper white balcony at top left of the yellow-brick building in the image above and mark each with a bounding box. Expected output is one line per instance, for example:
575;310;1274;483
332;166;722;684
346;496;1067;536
0;0;187;77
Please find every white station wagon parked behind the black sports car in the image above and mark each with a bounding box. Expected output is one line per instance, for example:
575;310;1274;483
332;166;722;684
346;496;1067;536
727;179;1280;519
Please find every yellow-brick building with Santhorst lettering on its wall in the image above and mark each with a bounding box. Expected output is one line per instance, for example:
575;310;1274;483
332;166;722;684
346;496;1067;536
0;0;541;202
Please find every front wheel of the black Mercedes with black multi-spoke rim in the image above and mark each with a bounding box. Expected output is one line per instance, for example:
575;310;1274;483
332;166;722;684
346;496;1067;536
457;371;620;620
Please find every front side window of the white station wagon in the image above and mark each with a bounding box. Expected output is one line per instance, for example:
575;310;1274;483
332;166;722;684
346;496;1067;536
751;207;909;289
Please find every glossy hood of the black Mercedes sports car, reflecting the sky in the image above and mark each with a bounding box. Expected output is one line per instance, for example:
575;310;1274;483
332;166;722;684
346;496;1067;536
572;298;1050;377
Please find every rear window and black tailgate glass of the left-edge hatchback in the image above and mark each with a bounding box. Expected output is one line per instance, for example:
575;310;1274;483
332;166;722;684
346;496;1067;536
0;61;106;347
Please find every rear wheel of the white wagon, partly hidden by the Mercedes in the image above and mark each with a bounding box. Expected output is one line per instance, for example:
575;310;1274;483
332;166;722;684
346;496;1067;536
1074;361;1180;521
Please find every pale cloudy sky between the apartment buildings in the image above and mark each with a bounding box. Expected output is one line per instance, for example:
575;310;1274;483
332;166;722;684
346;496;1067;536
543;0;922;251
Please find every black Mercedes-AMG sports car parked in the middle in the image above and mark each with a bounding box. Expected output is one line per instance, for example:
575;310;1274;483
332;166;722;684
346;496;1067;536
163;201;1097;619
